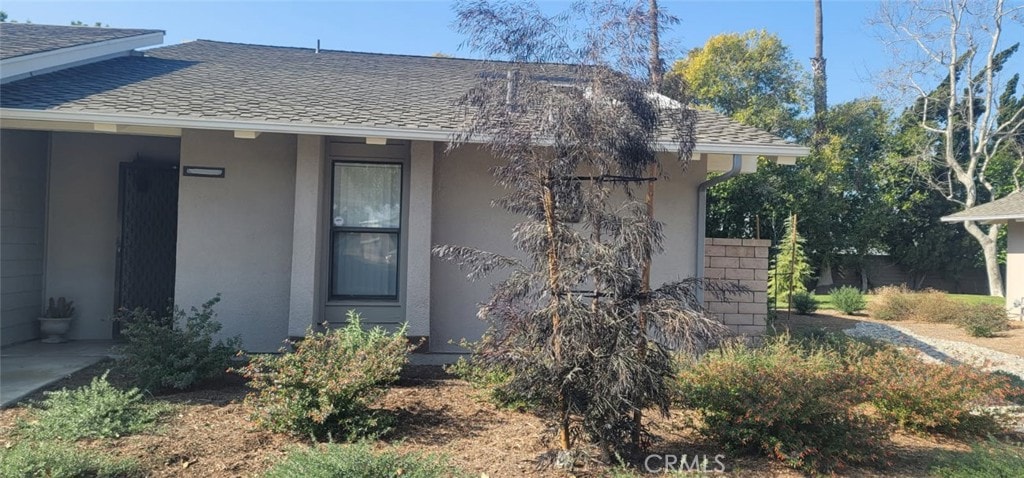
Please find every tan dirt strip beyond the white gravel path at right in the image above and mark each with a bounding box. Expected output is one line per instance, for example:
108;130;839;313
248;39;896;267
776;310;1024;356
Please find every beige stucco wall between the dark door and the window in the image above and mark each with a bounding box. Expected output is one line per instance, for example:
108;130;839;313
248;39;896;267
175;130;296;351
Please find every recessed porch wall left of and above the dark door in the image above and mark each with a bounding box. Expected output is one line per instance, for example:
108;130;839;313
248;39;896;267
45;132;178;339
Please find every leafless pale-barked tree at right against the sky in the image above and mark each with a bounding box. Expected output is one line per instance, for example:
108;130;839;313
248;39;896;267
876;0;1024;296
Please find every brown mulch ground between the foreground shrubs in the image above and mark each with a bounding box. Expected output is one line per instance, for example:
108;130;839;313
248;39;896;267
0;362;999;477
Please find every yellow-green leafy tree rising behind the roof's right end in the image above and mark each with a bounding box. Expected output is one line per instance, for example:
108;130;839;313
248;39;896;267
663;31;808;244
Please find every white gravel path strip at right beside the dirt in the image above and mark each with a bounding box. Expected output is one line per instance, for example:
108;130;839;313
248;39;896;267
845;322;1024;379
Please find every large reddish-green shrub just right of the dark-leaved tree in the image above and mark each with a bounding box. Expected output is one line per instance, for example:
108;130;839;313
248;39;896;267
679;336;887;471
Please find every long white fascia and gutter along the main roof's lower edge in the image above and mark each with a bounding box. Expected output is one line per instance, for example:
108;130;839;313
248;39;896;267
0;107;810;158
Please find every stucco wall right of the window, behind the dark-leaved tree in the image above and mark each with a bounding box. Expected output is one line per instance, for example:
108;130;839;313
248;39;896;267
430;146;707;352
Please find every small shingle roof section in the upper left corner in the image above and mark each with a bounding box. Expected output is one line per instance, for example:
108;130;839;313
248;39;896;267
0;23;163;59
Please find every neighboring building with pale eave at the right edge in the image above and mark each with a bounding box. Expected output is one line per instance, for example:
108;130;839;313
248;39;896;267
942;192;1024;319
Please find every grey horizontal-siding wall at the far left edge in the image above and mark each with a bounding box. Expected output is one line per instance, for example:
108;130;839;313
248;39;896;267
0;130;49;345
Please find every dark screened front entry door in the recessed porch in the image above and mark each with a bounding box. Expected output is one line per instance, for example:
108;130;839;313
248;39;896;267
114;160;178;337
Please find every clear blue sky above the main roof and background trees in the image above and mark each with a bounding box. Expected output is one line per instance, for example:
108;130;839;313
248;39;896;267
0;0;1024;103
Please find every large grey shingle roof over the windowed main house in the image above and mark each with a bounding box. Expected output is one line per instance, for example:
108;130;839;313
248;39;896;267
0;40;787;145
